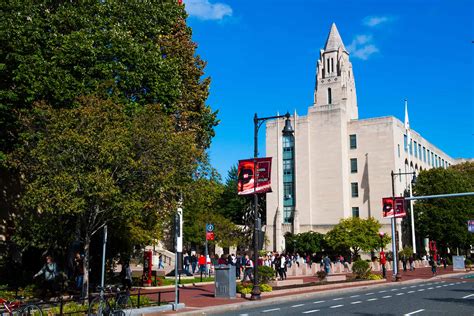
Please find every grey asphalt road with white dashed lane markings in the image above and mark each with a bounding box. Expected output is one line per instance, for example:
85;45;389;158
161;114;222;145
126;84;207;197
216;277;474;316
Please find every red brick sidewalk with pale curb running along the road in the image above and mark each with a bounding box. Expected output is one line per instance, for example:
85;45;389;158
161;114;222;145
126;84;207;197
137;266;470;316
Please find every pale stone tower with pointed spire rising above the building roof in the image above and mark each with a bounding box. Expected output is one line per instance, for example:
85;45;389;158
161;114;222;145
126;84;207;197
314;23;359;120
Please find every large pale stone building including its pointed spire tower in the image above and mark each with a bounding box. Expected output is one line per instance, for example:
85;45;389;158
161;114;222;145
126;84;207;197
265;24;454;251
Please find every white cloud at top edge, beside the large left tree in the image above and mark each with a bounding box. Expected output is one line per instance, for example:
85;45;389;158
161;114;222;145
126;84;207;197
184;0;232;20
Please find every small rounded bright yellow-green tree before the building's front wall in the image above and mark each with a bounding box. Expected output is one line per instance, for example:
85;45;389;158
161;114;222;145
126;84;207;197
326;217;390;258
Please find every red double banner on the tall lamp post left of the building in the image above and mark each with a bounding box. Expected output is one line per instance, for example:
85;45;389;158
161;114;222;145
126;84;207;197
237;157;272;195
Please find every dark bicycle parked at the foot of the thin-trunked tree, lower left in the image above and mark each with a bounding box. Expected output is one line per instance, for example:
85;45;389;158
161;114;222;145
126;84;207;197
88;286;133;316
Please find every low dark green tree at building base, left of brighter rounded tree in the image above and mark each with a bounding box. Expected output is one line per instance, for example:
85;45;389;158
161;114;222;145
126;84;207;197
285;231;327;254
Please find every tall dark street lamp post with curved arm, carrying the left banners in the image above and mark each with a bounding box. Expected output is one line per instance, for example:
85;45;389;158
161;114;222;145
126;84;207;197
250;112;293;300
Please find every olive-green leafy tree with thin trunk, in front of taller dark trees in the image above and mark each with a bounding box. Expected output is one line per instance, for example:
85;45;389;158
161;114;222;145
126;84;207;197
10;98;198;298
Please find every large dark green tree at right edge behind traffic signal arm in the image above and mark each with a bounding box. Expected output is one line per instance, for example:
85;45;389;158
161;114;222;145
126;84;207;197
413;162;474;253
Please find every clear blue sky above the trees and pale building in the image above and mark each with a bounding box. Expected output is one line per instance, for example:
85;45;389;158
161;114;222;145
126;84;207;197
184;0;474;179
